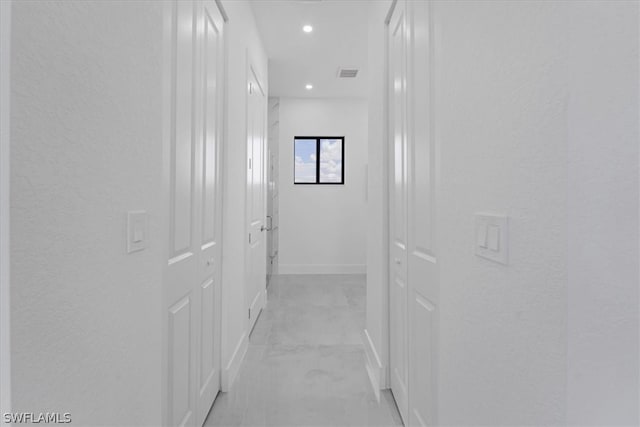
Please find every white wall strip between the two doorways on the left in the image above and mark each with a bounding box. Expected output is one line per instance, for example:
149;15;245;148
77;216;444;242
222;0;267;389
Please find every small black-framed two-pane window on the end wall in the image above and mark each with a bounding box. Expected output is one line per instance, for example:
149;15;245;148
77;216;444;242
293;136;344;184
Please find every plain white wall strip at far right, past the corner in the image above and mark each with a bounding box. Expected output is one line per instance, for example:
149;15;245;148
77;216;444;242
567;2;640;425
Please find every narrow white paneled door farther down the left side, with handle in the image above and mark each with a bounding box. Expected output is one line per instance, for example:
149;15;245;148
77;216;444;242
247;66;267;330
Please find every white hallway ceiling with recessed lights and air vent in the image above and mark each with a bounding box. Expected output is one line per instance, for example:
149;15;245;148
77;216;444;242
251;0;369;98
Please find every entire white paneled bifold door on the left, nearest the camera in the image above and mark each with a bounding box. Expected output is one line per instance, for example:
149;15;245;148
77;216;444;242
165;0;225;426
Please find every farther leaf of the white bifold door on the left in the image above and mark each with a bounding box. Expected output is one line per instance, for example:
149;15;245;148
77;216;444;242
196;0;224;426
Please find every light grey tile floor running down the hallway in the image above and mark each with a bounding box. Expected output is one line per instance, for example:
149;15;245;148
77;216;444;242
205;275;402;426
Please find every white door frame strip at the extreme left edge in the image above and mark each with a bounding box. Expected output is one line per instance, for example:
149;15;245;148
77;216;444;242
0;0;11;425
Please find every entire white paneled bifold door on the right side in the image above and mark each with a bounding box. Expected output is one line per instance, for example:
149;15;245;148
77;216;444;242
388;0;438;426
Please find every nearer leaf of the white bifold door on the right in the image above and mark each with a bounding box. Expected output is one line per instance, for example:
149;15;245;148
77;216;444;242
407;2;438;426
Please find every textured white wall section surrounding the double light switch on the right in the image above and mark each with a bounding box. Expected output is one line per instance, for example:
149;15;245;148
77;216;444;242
433;1;568;425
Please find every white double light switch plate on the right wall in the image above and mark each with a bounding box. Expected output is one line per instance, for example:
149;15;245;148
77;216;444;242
475;213;509;265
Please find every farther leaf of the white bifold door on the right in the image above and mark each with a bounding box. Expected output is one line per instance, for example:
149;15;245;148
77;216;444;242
388;2;409;424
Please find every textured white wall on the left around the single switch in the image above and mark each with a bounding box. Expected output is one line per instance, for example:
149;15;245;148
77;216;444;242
11;1;167;425
